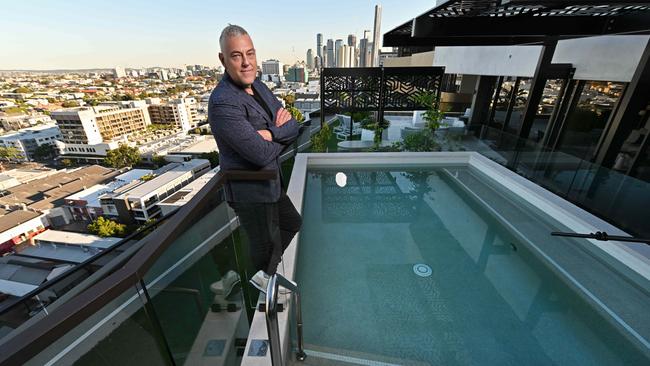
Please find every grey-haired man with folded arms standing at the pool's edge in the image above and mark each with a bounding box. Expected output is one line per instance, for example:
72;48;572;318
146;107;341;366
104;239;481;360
208;25;302;291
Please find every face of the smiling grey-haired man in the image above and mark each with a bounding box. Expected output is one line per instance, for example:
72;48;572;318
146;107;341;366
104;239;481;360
219;34;257;87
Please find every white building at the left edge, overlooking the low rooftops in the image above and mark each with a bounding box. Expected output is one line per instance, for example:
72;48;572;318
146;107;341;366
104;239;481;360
0;123;62;160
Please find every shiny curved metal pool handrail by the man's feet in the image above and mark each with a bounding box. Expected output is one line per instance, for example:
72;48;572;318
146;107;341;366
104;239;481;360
265;273;307;366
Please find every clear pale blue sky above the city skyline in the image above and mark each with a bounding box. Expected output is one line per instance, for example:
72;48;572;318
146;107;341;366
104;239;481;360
0;0;435;70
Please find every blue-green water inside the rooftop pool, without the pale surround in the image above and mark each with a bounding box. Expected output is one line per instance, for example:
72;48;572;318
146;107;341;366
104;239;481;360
297;167;648;365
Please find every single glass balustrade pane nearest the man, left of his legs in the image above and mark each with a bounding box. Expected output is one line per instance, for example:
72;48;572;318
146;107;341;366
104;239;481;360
138;191;249;365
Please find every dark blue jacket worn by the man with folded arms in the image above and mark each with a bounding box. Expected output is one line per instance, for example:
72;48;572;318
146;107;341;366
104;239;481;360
208;73;299;202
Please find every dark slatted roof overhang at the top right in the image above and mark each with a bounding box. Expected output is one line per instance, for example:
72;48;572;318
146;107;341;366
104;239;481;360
383;0;650;47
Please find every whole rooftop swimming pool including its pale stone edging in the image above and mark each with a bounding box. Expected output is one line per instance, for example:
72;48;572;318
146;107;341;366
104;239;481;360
238;153;650;365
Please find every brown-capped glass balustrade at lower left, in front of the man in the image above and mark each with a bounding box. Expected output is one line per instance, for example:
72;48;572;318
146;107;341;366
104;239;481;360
0;172;280;366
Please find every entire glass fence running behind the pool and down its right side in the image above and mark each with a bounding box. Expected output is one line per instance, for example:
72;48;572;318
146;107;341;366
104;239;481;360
305;112;650;237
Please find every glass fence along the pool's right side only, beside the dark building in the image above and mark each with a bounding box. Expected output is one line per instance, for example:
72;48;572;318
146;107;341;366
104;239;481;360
470;128;650;237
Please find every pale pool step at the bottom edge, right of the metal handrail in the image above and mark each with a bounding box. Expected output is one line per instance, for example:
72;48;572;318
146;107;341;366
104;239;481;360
289;345;428;366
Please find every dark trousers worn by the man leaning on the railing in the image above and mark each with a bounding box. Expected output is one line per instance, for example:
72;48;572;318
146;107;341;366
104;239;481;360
228;190;302;275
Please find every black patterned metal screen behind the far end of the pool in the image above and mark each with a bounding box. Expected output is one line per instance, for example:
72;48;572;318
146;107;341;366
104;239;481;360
321;67;444;115
